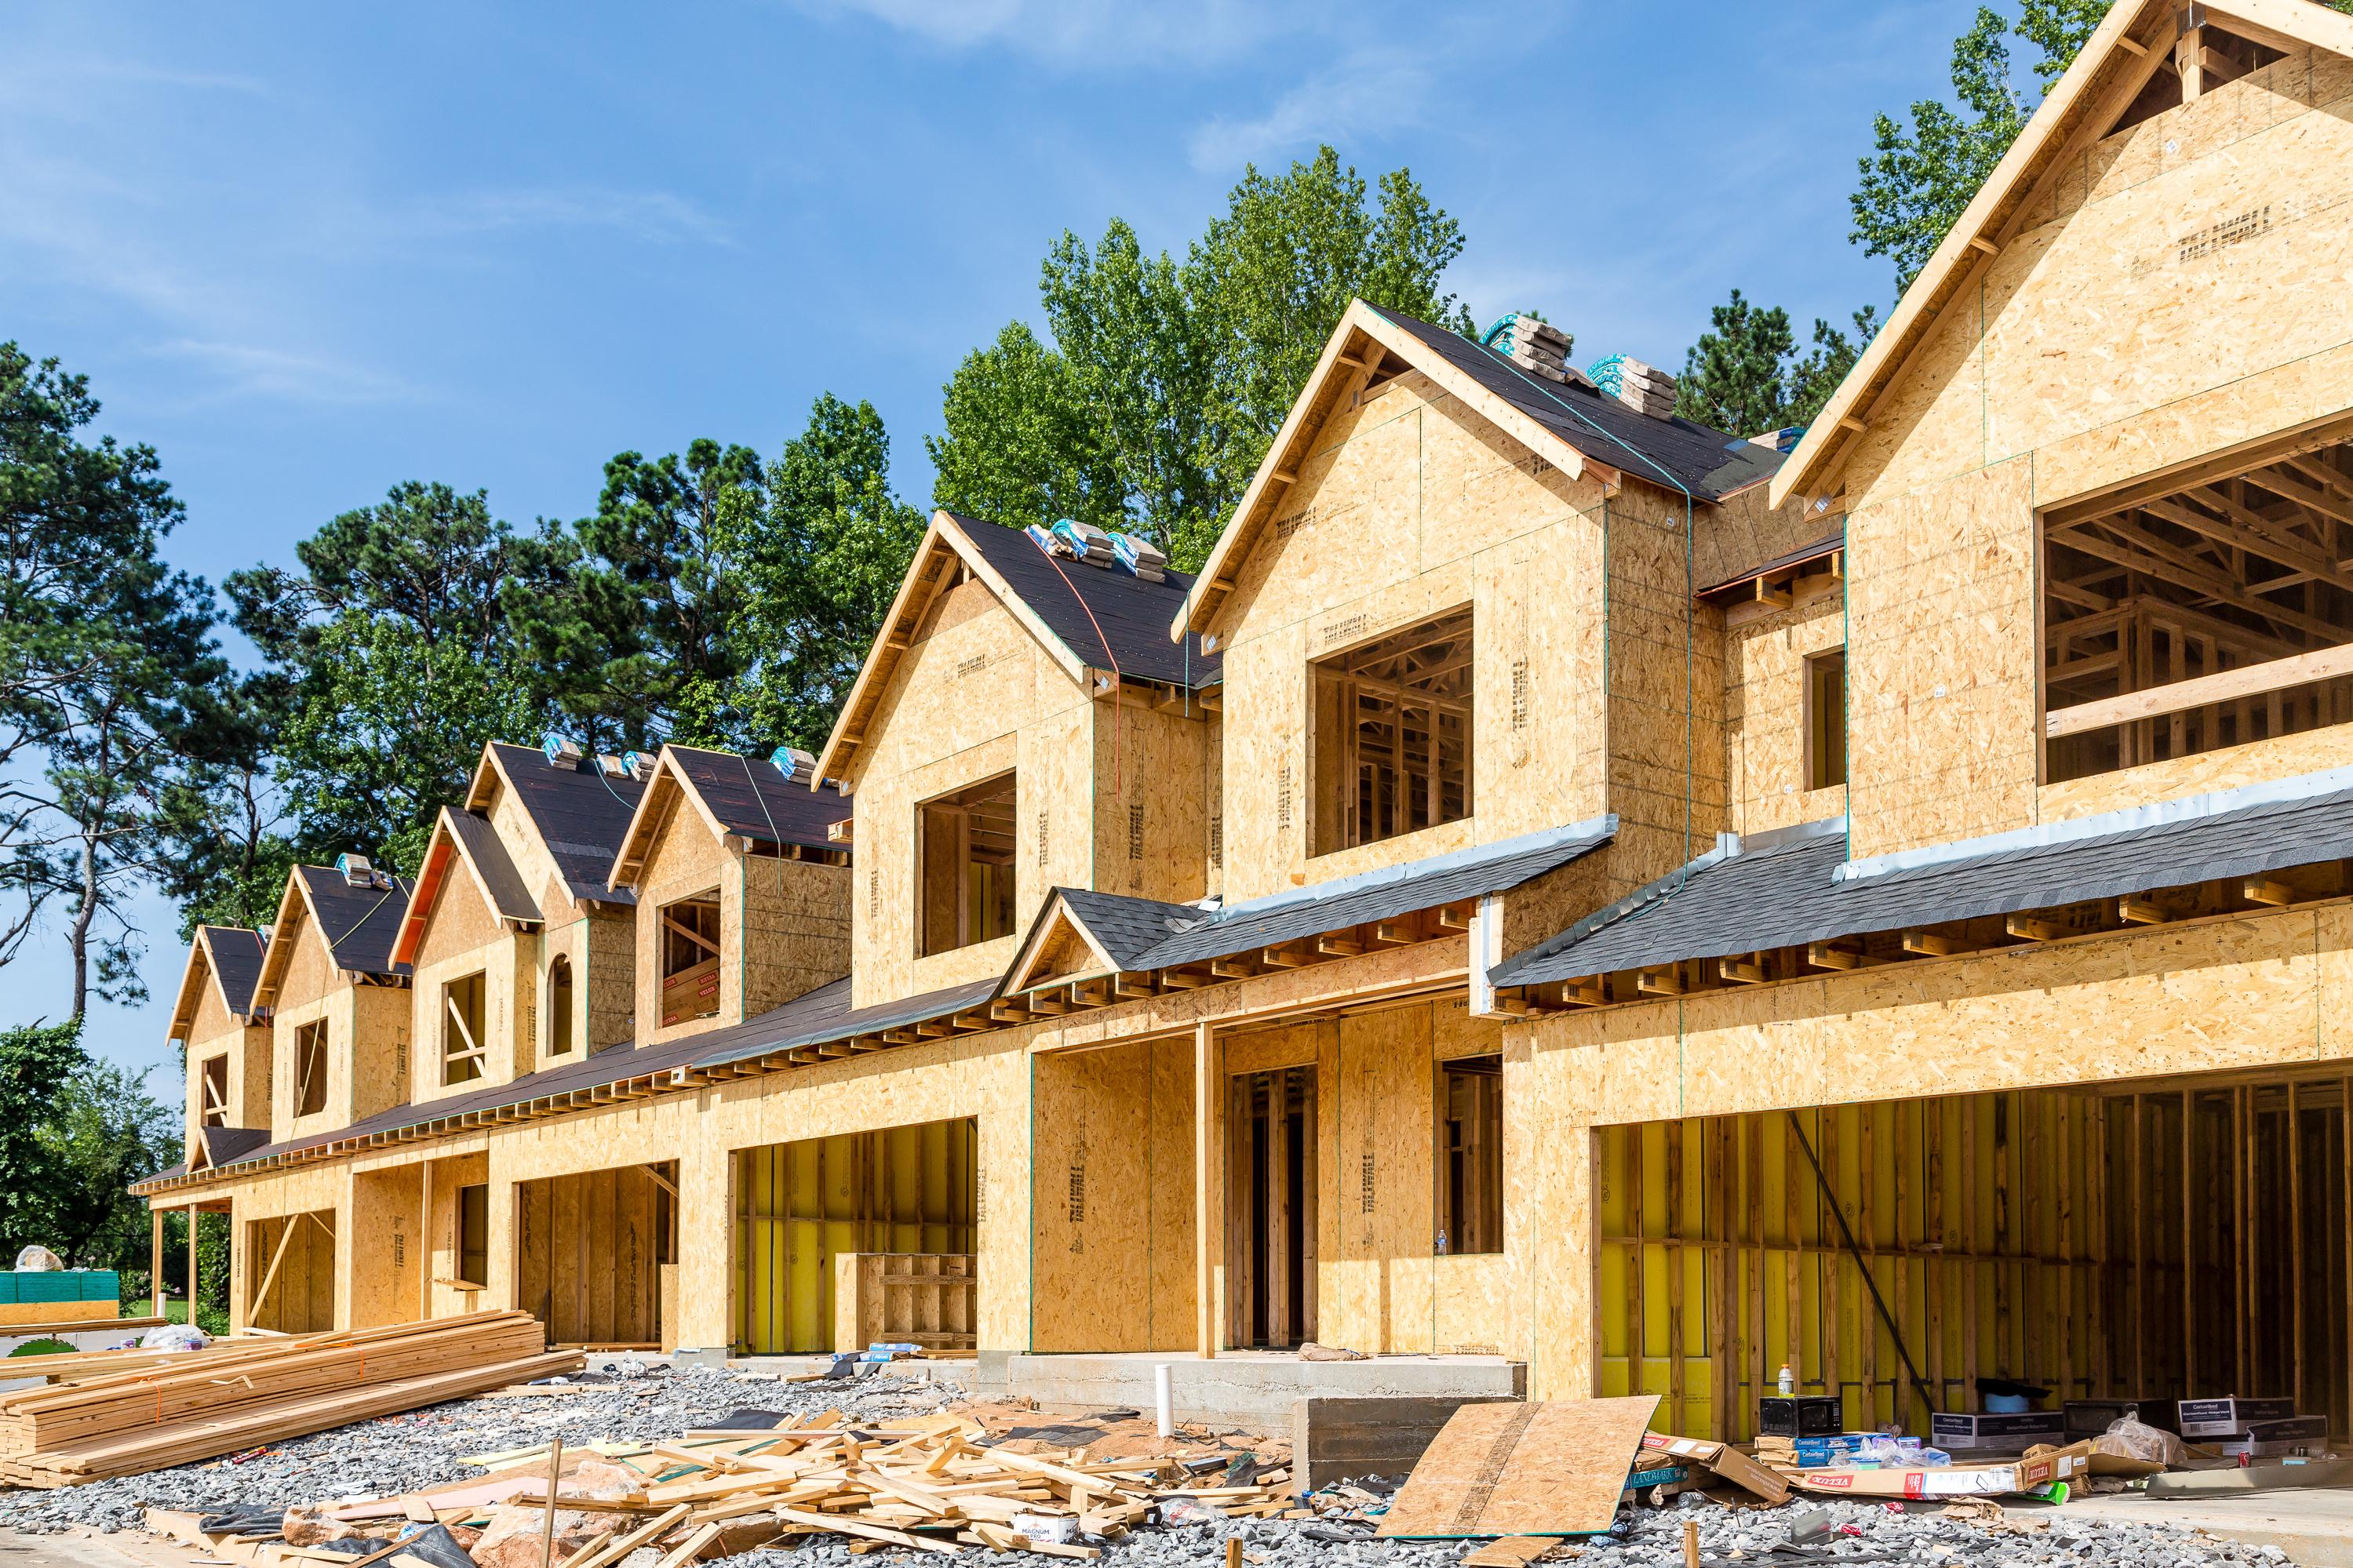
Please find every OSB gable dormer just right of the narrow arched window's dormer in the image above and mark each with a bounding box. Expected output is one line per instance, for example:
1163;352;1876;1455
607;745;850;1044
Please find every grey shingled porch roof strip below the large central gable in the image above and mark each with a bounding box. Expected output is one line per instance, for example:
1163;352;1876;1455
1030;816;1616;971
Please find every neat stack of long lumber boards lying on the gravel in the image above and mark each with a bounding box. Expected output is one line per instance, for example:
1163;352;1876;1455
0;1312;581;1488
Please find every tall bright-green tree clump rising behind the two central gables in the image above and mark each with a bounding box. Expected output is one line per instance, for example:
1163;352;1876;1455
930;148;1470;566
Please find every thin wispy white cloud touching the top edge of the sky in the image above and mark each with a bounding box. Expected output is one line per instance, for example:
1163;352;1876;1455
796;0;1310;68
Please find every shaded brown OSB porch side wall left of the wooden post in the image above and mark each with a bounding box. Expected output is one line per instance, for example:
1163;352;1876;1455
1035;1039;1195;1352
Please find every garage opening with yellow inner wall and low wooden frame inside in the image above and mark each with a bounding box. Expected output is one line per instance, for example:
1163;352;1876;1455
734;1117;979;1356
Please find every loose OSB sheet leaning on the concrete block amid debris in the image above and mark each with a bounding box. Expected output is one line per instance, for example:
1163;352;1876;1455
1381;1394;1659;1535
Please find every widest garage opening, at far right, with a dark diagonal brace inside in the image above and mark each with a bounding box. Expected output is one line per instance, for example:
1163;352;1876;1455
1593;1075;2353;1441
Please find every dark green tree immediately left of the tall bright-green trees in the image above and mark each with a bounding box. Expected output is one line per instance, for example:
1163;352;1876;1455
718;392;925;752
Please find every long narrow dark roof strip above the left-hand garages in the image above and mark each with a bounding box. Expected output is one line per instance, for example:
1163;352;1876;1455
163;980;998;1180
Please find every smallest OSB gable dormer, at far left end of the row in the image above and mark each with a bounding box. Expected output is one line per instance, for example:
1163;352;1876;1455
172;926;271;1171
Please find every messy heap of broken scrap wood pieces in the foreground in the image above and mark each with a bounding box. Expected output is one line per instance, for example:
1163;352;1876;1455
148;1410;1313;1568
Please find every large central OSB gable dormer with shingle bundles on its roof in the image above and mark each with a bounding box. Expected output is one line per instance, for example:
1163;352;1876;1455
1170;301;1821;936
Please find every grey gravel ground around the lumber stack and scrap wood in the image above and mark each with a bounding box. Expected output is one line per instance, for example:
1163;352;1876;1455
0;1368;2289;1568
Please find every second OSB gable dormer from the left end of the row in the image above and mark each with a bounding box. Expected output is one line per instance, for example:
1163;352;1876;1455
254;856;412;1141
